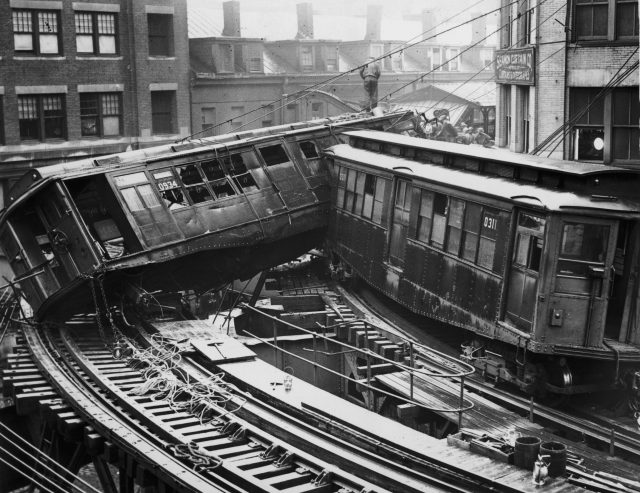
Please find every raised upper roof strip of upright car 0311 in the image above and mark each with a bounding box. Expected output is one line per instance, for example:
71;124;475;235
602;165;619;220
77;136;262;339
343;130;640;176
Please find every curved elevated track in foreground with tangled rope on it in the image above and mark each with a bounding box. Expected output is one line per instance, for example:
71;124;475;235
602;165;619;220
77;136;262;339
3;308;552;493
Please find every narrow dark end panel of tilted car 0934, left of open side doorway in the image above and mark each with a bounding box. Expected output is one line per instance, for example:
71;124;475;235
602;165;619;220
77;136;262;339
38;182;100;276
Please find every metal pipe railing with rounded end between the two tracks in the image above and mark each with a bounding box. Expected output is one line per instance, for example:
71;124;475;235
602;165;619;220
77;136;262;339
242;305;475;429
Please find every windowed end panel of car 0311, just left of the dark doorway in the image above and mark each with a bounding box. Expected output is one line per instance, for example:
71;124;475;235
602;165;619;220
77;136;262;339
546;217;618;347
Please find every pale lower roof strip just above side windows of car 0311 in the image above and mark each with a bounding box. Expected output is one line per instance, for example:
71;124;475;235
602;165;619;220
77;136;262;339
325;144;640;218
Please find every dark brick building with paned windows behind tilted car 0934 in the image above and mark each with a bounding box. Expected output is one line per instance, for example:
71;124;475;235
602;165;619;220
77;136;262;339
0;0;189;205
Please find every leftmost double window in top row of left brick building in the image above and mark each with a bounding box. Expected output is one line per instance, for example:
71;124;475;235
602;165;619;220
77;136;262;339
12;10;61;55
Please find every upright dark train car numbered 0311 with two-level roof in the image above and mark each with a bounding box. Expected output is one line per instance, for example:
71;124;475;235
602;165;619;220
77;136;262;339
326;131;640;394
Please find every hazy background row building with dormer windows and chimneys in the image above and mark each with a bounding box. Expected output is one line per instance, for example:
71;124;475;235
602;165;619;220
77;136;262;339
189;0;494;135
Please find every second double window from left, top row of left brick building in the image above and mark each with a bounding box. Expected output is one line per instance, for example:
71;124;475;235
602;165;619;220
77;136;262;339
75;12;118;55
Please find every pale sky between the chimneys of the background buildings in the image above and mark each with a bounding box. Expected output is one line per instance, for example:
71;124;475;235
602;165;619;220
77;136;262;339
187;0;499;45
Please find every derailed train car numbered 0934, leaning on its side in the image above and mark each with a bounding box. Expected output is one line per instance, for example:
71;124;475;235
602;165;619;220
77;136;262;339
0;114;408;319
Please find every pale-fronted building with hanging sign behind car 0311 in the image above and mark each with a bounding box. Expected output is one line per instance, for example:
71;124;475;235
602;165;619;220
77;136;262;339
496;0;640;166
